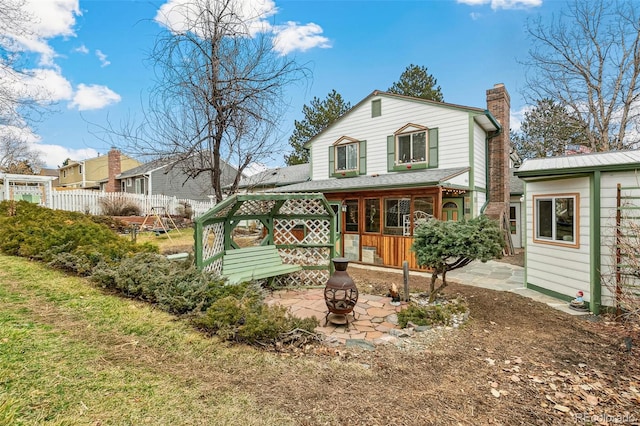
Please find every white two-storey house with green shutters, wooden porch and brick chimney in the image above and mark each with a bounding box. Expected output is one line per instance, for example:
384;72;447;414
272;84;510;269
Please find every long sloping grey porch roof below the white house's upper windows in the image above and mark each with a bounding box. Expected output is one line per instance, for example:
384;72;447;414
267;167;469;193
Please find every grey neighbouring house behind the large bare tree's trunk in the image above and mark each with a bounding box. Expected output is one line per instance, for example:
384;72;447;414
116;160;238;201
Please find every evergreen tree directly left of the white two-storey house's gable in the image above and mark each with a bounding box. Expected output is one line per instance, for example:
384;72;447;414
284;89;351;166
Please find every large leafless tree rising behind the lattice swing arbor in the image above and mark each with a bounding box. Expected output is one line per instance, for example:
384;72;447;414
111;0;306;201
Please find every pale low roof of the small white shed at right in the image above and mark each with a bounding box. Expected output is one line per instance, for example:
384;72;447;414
515;150;640;178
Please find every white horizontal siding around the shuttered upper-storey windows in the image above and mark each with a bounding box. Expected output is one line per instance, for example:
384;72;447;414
311;96;470;180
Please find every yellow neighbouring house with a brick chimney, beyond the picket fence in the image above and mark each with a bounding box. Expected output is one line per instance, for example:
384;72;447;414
58;148;142;192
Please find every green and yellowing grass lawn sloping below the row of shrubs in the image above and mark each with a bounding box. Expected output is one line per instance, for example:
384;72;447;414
0;256;300;425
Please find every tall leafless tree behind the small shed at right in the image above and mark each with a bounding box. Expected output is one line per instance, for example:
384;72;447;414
525;0;640;151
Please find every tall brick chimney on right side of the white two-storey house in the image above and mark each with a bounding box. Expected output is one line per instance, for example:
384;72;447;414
485;83;511;230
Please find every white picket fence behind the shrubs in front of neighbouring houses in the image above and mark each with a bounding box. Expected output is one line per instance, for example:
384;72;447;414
47;189;215;218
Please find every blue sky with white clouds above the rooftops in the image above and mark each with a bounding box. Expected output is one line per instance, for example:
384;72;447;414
6;0;564;167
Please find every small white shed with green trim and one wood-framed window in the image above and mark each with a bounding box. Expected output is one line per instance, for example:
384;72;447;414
515;151;640;313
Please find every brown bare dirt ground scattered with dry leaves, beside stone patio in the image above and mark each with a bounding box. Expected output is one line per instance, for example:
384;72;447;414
264;258;640;425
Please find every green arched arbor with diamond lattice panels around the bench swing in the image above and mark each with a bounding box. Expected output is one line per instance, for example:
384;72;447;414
195;193;336;287
